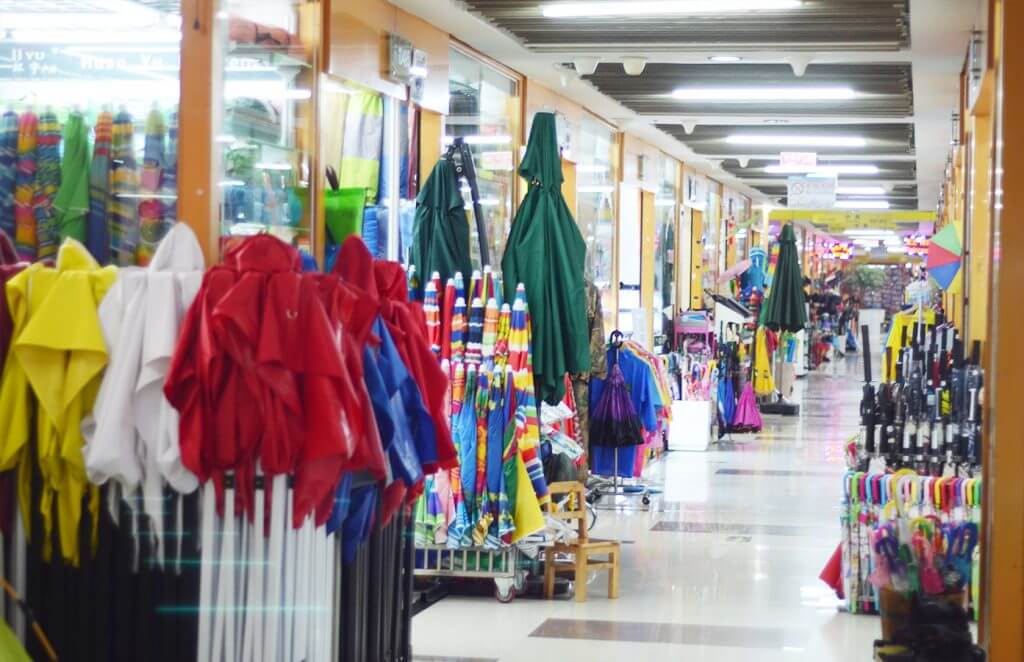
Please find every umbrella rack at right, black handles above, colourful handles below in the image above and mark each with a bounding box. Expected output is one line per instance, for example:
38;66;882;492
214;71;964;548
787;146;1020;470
822;323;984;627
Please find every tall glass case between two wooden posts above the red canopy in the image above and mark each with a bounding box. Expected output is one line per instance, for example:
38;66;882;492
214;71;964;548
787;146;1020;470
213;0;319;254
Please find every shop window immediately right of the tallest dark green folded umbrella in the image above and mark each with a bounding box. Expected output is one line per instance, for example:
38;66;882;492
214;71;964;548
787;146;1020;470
574;119;616;334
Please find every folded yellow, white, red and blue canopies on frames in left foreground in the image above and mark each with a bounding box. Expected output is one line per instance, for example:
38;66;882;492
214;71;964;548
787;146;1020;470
0;225;448;661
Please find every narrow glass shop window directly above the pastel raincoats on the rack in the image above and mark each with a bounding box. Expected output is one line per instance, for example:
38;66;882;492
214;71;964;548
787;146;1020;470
653;156;679;350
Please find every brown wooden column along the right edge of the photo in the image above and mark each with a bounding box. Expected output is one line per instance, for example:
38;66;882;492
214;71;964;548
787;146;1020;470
971;1;1024;662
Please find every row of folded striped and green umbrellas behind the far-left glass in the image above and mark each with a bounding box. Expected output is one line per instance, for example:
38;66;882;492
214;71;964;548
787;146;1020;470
0;108;177;265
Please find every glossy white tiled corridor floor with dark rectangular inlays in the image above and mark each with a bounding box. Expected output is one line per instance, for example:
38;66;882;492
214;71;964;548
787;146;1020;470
413;359;881;662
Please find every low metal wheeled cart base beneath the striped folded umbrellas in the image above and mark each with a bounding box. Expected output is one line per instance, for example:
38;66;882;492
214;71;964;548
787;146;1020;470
414;545;525;603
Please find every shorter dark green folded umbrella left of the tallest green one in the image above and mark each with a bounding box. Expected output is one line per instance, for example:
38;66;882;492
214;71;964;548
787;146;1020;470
409;159;472;297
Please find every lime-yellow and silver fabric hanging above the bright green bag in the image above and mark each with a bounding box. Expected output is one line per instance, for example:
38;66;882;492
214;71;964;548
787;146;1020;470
338;91;384;205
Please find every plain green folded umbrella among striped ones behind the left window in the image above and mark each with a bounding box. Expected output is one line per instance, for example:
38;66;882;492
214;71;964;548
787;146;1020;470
53;113;89;243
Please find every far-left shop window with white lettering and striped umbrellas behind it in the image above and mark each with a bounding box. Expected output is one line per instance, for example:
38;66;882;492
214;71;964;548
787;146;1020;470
0;0;181;265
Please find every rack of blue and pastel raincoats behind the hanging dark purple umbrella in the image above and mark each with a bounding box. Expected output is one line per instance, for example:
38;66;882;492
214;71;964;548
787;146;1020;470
590;340;672;478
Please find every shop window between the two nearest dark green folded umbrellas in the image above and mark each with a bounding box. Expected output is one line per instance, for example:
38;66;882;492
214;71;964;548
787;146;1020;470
444;48;521;267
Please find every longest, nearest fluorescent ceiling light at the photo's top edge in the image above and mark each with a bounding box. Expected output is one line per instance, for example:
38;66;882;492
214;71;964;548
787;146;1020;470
541;0;803;18
